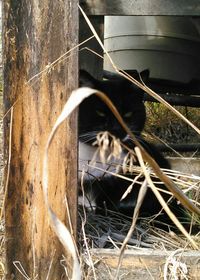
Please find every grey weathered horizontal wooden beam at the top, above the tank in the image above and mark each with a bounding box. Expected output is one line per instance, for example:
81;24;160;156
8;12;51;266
80;0;200;16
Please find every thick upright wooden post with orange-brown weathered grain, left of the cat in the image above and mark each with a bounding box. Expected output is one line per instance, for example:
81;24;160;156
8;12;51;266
4;0;78;280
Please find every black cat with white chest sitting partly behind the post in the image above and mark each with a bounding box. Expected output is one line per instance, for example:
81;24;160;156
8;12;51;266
79;70;186;229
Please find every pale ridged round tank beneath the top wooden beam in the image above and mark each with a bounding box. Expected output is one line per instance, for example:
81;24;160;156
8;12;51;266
104;16;200;83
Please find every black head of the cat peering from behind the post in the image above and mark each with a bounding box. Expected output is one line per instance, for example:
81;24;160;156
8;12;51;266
79;70;146;142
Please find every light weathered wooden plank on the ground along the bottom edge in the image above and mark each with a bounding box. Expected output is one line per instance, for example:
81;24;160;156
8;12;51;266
89;249;200;280
